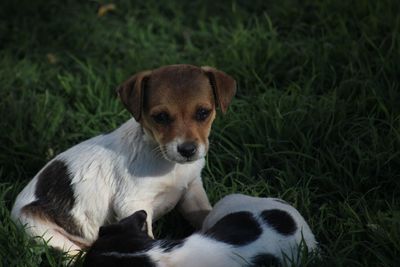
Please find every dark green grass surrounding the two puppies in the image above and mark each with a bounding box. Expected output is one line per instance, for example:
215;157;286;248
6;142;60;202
0;0;400;266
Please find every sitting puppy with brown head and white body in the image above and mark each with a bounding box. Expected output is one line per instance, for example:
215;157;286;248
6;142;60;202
12;65;236;254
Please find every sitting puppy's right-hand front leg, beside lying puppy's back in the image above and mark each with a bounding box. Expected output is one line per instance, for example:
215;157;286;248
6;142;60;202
178;177;212;229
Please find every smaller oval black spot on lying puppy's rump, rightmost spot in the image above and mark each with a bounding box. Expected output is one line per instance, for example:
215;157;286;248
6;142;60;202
261;209;297;235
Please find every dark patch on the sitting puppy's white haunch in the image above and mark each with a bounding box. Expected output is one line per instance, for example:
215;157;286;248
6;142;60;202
23;160;82;236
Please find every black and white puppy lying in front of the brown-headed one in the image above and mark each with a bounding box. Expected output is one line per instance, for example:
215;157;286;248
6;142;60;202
85;194;317;267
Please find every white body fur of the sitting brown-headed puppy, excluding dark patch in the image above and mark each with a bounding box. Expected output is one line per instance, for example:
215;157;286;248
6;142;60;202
12;119;211;253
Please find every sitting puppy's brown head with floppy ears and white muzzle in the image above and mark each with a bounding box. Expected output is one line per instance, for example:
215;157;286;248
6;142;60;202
118;65;236;163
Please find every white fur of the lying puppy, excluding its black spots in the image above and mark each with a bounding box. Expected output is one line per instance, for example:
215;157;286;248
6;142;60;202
96;194;317;267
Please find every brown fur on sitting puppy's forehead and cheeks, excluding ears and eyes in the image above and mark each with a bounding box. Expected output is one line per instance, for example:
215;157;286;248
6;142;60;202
142;65;215;147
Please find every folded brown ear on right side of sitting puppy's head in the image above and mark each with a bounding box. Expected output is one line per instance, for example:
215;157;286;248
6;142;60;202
201;66;236;114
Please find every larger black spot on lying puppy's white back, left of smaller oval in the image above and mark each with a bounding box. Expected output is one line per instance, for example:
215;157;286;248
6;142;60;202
205;211;262;246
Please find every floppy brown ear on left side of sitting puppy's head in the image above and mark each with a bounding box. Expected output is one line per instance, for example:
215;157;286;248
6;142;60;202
117;70;151;122
